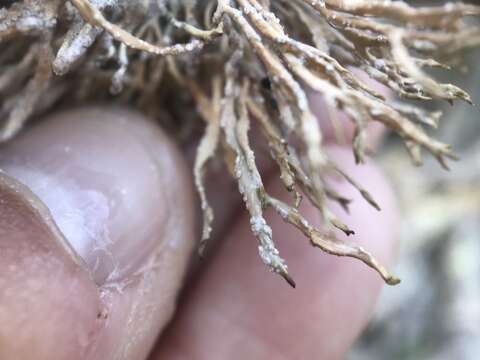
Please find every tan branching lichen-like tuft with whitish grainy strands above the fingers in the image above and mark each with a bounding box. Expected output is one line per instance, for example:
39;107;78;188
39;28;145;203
0;0;480;285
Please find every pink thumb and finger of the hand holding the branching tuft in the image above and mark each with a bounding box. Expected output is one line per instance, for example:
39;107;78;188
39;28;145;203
0;100;398;360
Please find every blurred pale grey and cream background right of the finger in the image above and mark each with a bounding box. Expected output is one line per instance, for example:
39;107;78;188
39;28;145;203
347;28;480;360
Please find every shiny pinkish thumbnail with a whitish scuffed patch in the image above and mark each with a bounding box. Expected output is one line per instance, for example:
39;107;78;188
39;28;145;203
0;108;189;285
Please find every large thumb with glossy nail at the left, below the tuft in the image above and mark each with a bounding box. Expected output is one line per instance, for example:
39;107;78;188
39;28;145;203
0;108;194;360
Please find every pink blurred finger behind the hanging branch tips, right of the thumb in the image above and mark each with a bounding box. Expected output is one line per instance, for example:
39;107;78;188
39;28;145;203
154;148;397;359
